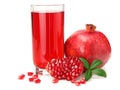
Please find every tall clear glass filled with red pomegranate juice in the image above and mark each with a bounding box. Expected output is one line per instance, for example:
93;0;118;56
31;4;64;74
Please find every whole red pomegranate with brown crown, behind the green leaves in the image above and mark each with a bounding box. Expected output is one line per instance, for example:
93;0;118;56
65;24;111;66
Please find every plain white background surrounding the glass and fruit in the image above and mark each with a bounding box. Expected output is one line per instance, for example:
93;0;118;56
0;0;120;90
